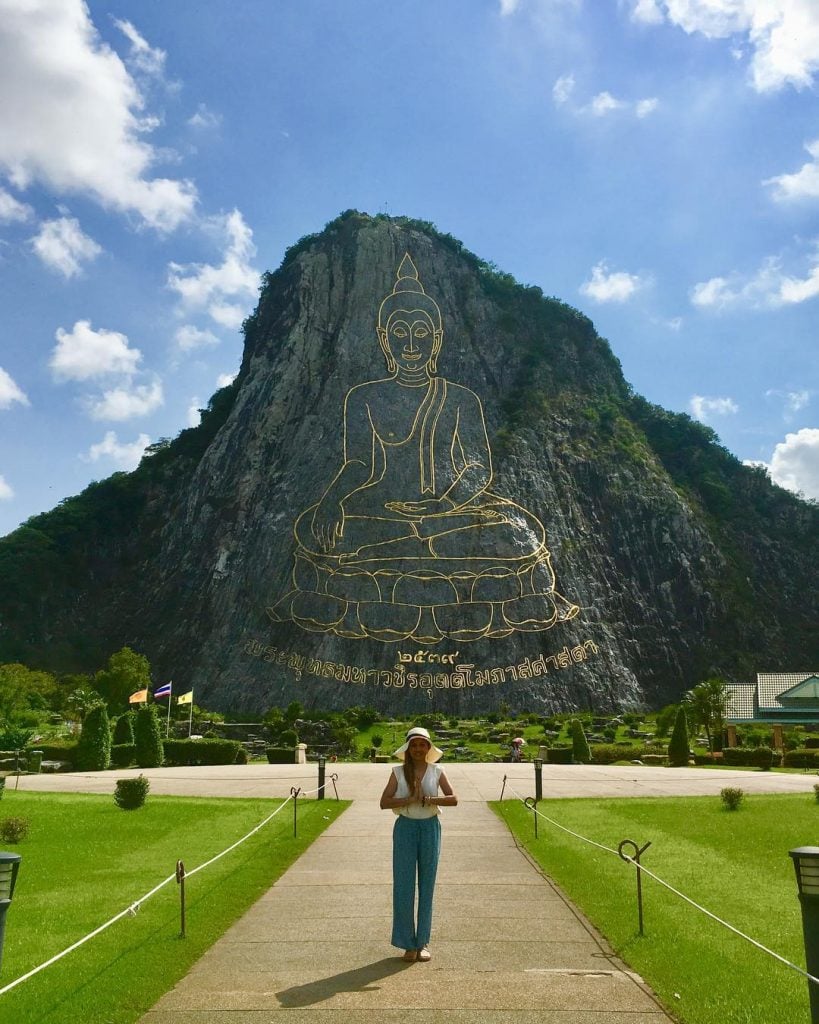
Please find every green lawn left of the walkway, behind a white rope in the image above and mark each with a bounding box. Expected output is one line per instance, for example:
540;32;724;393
0;792;348;1024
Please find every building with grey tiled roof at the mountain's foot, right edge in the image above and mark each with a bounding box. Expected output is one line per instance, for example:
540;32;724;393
725;672;819;725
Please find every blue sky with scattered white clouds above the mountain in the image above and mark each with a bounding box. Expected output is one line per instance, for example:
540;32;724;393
0;0;819;536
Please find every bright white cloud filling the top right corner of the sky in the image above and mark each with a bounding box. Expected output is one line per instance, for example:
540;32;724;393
632;0;819;92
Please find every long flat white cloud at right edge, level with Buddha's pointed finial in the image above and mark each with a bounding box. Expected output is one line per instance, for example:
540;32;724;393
691;255;819;309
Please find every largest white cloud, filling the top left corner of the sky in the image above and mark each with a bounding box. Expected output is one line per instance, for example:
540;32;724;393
0;0;197;231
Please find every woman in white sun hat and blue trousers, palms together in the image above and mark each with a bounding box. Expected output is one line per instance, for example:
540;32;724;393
381;727;458;963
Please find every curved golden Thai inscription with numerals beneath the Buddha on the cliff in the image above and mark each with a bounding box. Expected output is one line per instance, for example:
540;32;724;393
242;637;599;698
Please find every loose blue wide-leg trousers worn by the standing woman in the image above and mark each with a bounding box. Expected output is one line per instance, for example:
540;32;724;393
392;814;441;949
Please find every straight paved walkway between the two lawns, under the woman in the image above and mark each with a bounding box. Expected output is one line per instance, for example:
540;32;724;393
140;798;671;1024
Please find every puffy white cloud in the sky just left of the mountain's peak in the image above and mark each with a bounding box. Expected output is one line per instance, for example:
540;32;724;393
168;210;259;327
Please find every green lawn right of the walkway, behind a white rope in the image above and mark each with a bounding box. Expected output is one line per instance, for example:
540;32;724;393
492;794;819;1024
